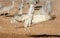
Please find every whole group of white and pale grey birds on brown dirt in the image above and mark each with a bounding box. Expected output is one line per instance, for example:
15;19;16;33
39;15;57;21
0;0;52;28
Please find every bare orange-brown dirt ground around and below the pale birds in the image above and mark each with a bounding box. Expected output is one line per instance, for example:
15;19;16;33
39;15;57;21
0;0;60;38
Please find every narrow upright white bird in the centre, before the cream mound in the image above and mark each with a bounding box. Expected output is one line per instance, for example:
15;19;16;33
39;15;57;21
24;4;34;28
